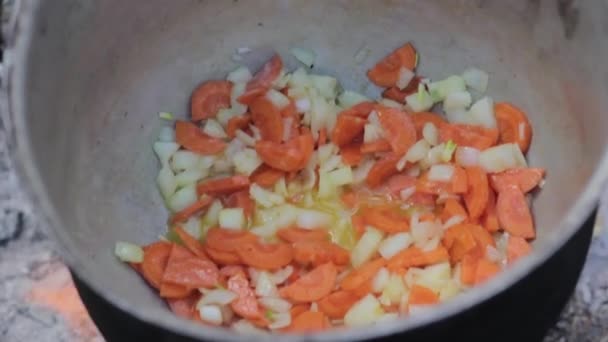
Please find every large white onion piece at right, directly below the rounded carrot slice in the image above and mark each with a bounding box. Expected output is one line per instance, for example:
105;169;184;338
479;143;527;173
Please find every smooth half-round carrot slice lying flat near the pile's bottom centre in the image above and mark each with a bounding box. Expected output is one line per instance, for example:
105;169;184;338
279;262;337;302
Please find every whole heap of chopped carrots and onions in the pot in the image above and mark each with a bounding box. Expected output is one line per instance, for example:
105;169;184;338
115;43;545;333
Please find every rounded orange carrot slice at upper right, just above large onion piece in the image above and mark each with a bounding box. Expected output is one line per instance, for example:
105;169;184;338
494;102;532;153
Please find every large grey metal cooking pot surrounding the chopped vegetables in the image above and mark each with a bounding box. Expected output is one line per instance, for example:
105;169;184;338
1;0;608;341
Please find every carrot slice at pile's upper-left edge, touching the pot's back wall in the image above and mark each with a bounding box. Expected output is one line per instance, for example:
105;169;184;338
190;81;232;121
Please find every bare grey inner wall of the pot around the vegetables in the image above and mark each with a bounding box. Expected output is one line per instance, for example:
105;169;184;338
19;0;608;336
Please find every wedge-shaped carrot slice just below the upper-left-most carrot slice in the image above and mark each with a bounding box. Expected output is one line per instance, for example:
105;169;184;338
175;120;227;155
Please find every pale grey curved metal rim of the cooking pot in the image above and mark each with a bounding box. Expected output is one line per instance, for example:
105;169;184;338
0;0;608;341
